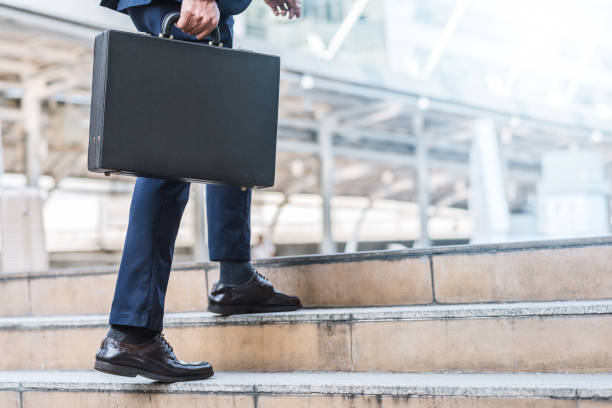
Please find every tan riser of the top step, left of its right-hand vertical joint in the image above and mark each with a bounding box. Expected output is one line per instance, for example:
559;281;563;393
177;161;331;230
0;258;432;316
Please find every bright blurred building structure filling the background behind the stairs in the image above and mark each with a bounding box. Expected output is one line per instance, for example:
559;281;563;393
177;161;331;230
0;0;612;263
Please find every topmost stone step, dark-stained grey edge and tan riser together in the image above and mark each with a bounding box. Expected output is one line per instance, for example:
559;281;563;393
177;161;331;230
0;237;612;316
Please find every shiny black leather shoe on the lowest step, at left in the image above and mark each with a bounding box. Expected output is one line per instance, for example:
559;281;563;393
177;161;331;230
94;333;214;382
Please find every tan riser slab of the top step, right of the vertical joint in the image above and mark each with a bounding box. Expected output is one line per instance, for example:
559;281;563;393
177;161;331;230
432;246;612;303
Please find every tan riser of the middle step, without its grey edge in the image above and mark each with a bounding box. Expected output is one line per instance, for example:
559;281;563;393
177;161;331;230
0;314;612;373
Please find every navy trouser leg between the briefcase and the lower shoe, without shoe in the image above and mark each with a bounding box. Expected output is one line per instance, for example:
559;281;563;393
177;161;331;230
110;178;189;331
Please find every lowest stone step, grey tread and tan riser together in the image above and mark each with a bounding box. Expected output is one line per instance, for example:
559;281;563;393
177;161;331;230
0;371;612;408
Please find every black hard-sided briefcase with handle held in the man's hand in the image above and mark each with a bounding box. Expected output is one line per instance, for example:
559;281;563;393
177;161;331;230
88;13;280;187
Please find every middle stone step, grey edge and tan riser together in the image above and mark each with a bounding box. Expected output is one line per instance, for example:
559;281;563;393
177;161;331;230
0;300;612;373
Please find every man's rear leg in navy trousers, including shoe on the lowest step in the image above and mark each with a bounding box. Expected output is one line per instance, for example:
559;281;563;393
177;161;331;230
94;1;213;382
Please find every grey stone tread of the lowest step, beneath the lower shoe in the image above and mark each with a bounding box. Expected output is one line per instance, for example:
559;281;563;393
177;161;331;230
0;371;612;399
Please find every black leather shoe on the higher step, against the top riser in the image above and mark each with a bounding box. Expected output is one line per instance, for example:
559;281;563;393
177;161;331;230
208;271;302;316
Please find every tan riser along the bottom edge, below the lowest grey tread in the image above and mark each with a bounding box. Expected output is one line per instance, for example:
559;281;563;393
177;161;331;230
0;391;612;408
